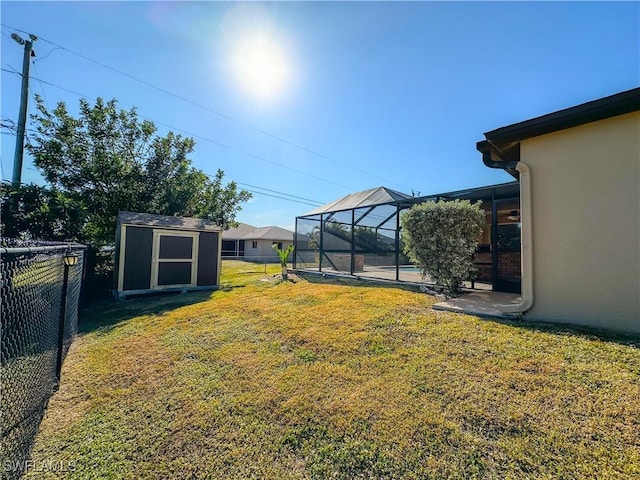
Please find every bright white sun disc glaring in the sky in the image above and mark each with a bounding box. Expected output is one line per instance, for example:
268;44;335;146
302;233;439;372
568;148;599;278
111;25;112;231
232;37;291;99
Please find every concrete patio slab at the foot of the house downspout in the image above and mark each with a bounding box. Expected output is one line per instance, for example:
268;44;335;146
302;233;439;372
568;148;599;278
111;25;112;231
432;291;522;319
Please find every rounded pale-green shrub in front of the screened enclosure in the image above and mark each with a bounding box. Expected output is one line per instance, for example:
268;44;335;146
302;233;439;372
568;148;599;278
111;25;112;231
400;200;485;294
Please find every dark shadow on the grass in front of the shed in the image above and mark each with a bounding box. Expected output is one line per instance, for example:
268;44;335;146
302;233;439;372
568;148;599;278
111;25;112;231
78;286;215;334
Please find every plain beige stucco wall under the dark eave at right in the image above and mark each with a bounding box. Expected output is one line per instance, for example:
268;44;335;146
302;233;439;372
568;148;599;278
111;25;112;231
520;112;640;333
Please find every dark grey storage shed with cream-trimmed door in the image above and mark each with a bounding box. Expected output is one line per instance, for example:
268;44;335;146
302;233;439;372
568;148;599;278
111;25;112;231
114;212;222;298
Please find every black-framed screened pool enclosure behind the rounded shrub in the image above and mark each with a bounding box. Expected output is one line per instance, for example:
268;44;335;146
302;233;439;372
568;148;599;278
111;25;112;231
293;182;520;292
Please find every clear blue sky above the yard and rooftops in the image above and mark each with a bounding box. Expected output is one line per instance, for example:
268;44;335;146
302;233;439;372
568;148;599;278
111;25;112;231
0;1;640;228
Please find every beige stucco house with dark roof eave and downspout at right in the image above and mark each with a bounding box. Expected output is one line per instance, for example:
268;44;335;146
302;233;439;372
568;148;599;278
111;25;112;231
477;88;640;333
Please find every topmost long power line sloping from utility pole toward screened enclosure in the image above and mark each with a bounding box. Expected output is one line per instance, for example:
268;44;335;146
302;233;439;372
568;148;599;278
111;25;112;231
0;23;416;188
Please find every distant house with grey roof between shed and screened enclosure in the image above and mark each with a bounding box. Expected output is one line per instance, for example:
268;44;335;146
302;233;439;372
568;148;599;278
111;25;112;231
222;223;293;262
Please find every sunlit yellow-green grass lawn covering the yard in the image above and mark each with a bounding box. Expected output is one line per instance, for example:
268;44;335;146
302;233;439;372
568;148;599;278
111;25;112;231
26;261;640;479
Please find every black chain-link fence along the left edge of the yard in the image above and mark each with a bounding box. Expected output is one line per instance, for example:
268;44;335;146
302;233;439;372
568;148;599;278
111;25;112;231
0;239;85;479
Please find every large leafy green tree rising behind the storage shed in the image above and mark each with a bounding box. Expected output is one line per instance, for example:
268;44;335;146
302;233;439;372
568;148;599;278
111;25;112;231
27;97;251;247
